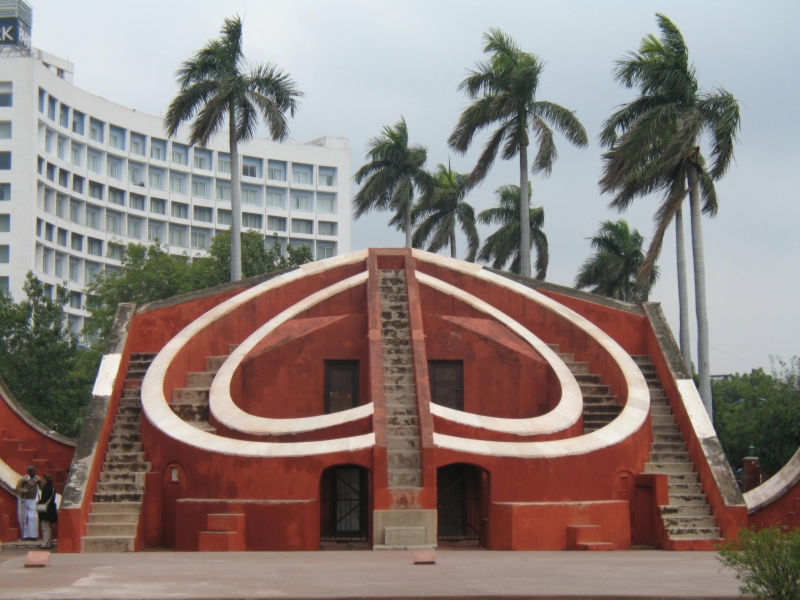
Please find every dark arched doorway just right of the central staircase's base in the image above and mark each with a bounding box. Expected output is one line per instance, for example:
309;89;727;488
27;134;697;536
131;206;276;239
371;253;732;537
436;465;481;541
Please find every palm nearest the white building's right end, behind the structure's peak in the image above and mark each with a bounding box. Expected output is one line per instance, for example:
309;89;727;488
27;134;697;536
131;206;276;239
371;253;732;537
353;117;433;248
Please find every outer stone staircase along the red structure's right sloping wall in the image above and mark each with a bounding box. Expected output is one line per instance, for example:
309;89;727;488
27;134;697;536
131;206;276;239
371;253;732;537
632;356;721;549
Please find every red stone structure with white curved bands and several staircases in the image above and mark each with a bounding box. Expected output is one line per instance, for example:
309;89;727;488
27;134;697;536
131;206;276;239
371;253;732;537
4;249;800;552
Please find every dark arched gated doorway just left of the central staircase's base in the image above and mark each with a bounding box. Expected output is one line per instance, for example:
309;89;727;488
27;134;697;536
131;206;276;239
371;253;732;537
320;466;369;542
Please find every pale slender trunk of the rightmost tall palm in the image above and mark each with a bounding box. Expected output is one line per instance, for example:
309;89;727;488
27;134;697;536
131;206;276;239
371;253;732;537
688;164;714;422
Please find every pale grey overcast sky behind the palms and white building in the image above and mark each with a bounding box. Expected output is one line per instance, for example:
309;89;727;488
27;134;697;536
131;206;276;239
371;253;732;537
29;0;800;373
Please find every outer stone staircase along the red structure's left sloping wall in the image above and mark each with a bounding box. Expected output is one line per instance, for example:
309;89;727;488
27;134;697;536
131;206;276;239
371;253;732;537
81;354;155;552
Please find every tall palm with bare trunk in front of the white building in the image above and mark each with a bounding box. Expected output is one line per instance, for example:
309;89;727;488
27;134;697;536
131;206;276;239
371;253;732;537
164;16;303;281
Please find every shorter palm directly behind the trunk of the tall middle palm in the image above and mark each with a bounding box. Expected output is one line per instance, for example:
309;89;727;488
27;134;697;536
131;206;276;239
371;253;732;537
478;185;550;281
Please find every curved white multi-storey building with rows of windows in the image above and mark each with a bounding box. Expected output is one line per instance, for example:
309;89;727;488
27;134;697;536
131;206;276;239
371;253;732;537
0;41;350;332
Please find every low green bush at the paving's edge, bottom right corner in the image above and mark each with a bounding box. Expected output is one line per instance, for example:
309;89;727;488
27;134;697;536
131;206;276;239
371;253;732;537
718;527;800;600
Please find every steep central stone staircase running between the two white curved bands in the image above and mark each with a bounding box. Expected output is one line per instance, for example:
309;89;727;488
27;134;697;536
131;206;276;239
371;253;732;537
379;270;422;488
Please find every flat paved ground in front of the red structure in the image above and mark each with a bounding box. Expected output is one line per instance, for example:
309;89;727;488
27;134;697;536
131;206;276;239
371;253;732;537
0;550;739;600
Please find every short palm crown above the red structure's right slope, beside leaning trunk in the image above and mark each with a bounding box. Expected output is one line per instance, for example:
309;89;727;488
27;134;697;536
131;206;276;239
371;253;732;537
575;219;659;302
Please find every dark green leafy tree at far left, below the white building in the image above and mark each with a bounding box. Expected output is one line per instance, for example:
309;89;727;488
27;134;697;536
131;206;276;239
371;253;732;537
0;272;100;438
